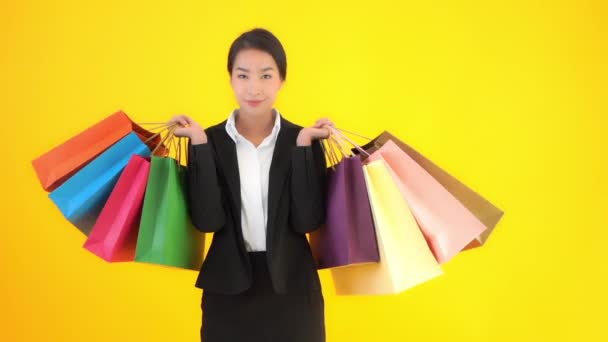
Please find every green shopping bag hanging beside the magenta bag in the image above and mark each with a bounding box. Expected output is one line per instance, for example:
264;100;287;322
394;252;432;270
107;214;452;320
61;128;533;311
135;156;205;270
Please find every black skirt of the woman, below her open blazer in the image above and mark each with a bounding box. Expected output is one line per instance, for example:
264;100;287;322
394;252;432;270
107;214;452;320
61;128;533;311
201;252;325;342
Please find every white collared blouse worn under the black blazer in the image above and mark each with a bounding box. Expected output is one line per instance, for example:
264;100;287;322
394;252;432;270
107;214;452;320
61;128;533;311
226;108;281;252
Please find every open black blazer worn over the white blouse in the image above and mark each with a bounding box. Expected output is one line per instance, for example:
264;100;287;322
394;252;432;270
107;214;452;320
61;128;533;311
187;116;327;294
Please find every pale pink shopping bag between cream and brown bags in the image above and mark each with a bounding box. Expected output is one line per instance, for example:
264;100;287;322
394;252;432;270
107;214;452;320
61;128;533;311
369;140;486;263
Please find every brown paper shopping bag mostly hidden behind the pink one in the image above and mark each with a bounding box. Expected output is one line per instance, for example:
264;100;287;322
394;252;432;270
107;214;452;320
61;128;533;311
350;130;504;249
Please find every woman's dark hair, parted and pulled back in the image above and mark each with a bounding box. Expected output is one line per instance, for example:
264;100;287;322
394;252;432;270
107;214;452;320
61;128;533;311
228;28;287;81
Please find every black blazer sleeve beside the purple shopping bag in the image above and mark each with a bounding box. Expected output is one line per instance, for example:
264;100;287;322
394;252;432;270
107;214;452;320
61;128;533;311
289;140;327;234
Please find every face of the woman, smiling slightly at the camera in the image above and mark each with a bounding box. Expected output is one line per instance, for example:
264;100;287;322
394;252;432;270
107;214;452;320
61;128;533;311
230;49;284;115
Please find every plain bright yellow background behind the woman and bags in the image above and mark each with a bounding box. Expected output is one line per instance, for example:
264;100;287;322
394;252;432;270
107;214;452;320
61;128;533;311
0;0;608;342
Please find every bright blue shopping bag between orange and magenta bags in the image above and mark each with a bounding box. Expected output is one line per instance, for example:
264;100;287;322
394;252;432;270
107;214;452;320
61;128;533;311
49;132;150;236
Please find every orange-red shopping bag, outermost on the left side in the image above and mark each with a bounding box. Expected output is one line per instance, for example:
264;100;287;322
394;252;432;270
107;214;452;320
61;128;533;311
32;111;167;191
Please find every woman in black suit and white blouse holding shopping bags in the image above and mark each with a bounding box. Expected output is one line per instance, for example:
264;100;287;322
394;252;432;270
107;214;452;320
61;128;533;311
171;28;333;342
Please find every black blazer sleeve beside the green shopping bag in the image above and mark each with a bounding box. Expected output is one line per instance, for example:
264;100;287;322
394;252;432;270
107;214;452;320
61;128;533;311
186;135;226;233
